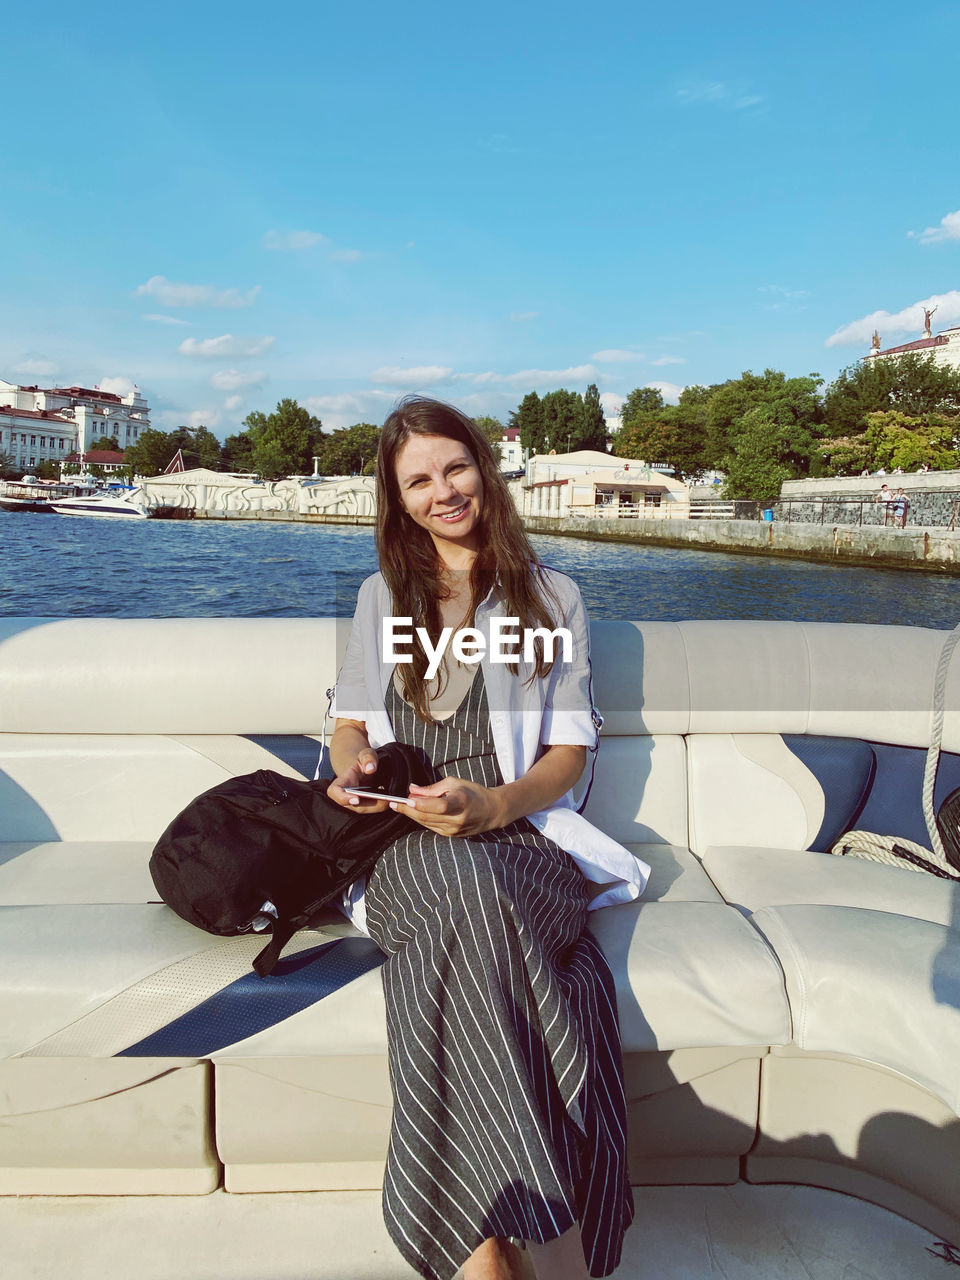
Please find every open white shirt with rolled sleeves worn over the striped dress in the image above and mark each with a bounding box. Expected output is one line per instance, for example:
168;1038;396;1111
333;566;650;929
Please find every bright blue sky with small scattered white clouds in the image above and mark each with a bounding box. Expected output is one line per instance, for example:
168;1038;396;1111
0;0;960;438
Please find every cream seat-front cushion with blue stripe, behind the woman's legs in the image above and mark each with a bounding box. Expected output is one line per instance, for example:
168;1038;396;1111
0;901;790;1059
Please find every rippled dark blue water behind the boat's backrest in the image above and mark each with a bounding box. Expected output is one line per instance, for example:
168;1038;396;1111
0;512;960;627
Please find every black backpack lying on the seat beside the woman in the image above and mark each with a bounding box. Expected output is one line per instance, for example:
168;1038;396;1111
150;742;434;978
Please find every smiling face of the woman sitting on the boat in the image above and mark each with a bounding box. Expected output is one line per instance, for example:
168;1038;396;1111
397;435;484;556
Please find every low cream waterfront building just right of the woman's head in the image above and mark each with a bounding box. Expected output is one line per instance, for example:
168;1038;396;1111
521;449;690;517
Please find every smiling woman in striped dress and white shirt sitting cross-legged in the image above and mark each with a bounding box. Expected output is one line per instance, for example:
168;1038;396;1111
329;398;646;1280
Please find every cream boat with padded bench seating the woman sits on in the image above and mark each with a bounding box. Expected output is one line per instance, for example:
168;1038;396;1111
0;617;960;1280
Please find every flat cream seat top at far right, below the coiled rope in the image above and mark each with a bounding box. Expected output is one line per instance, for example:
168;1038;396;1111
703;845;960;928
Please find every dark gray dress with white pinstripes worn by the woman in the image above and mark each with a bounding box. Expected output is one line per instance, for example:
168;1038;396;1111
366;678;634;1280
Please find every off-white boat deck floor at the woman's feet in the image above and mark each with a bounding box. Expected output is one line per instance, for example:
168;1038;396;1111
0;1183;960;1280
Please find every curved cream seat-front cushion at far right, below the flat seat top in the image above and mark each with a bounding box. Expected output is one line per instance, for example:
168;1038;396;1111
751;905;960;1112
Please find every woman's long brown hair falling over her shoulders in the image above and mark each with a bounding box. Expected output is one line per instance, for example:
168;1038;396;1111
376;396;562;721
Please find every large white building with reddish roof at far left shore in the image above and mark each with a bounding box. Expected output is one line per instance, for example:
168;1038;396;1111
0;379;150;472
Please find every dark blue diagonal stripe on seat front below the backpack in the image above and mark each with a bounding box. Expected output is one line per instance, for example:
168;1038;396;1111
116;936;385;1057
